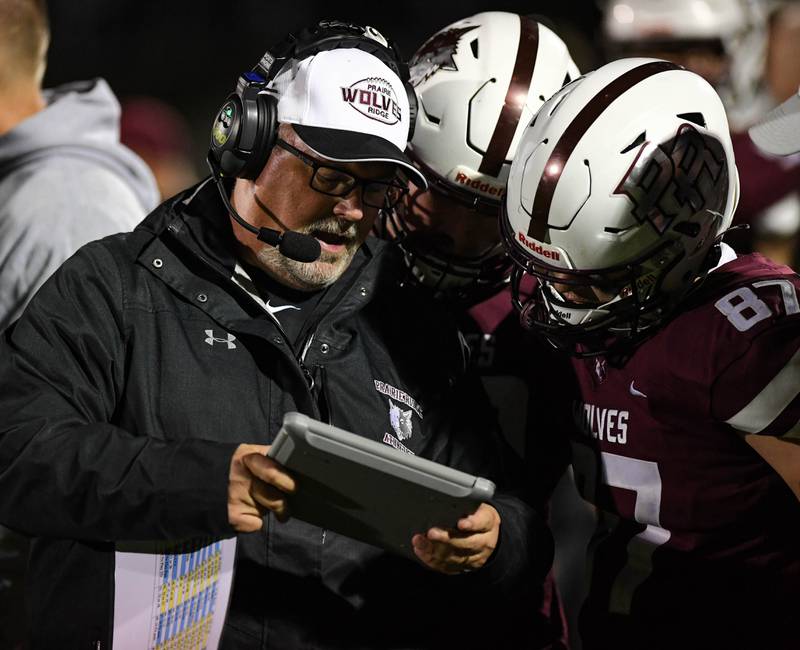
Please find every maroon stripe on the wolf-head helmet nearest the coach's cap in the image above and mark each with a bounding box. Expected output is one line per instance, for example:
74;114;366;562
478;16;539;176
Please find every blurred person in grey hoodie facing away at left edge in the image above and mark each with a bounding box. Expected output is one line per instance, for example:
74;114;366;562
0;0;158;648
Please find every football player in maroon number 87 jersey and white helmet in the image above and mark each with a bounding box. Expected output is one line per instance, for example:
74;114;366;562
501;59;800;649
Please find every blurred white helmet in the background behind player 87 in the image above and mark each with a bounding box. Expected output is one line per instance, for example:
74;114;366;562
603;0;777;129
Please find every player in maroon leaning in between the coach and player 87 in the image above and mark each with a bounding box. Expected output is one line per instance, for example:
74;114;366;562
380;12;592;648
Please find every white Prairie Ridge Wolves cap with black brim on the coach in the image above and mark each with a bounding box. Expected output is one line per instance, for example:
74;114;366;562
270;48;428;188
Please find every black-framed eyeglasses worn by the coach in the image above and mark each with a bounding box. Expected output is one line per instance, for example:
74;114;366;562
275;138;408;208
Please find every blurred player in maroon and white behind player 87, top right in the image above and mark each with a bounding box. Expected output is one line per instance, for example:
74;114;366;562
603;0;800;264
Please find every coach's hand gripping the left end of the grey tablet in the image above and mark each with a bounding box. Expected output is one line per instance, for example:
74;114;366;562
228;445;295;533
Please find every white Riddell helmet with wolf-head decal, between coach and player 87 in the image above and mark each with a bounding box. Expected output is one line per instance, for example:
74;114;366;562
385;11;579;297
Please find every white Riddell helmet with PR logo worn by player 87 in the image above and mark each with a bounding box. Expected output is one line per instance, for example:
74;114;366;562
501;59;739;354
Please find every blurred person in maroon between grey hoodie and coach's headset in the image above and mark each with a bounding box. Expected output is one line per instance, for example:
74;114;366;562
120;97;199;199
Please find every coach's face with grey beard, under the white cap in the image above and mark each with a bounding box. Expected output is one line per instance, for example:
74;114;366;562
231;124;395;291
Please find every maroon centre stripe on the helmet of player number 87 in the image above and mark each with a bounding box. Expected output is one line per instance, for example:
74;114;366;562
528;61;683;241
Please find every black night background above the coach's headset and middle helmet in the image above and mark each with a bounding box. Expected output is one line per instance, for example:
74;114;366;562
37;0;600;164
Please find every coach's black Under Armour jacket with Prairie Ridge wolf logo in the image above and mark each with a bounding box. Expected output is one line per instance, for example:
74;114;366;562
0;178;551;649
